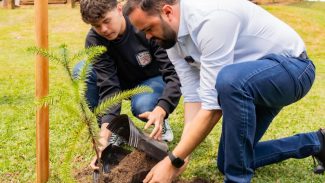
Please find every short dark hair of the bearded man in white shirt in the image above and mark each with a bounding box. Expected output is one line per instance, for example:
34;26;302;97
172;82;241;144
123;0;178;15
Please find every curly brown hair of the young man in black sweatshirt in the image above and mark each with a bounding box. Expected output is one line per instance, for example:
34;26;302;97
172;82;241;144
80;0;118;24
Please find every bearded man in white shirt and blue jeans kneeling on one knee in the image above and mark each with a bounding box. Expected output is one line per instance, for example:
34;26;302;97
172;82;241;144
125;0;325;183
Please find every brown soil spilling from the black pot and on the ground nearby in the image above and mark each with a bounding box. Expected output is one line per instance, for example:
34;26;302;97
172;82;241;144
75;150;209;183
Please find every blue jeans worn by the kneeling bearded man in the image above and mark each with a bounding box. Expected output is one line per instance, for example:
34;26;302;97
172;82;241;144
216;54;321;182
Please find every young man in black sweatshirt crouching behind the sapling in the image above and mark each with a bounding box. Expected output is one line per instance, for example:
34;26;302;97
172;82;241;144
75;0;181;169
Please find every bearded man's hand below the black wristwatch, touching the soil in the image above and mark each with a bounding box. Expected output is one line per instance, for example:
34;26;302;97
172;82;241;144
143;157;176;183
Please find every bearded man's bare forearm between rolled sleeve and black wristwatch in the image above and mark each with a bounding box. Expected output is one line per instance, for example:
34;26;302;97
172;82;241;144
173;109;222;159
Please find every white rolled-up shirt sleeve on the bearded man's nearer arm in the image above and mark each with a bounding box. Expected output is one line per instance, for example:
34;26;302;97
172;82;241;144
192;11;240;110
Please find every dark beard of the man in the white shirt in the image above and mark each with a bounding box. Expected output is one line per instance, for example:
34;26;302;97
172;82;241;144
154;19;176;49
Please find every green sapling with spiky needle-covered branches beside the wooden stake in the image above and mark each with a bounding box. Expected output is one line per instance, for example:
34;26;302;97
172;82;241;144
27;44;152;181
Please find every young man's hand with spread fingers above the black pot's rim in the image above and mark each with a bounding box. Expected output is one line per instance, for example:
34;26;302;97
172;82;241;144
139;106;166;140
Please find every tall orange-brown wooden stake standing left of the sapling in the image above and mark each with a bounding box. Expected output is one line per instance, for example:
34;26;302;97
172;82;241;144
34;0;49;183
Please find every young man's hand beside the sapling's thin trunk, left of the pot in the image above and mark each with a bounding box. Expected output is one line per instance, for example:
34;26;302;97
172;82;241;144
89;123;112;170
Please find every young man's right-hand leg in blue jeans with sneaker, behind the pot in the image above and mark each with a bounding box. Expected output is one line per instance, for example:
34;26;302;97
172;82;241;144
131;76;174;142
